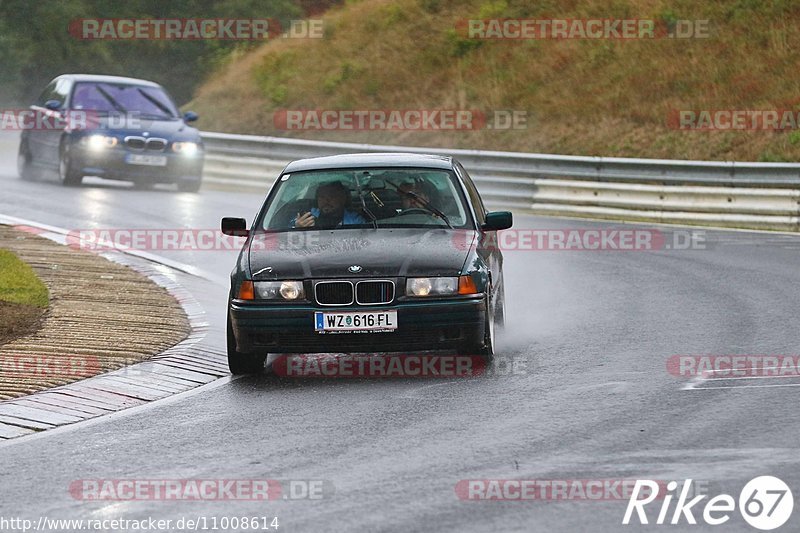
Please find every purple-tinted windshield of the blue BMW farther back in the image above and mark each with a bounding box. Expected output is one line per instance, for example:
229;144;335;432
71;82;178;119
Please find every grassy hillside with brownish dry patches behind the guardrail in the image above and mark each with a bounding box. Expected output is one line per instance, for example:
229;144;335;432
185;0;800;161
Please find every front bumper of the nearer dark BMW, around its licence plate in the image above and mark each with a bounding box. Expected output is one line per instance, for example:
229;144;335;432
229;295;486;353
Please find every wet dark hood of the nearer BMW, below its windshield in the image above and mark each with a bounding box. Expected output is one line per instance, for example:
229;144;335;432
250;228;476;280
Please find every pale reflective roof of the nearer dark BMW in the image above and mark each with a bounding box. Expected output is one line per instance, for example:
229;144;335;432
284;152;453;173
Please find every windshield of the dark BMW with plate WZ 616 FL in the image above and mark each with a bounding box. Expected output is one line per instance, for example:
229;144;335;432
256;168;470;231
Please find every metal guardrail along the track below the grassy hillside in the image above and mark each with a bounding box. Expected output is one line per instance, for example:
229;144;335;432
203;132;800;231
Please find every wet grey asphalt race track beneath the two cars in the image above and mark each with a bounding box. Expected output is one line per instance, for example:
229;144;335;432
0;130;800;532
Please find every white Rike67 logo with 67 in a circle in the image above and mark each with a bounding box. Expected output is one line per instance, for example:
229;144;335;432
622;476;794;531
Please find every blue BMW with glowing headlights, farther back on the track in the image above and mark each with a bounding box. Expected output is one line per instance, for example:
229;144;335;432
17;74;203;192
